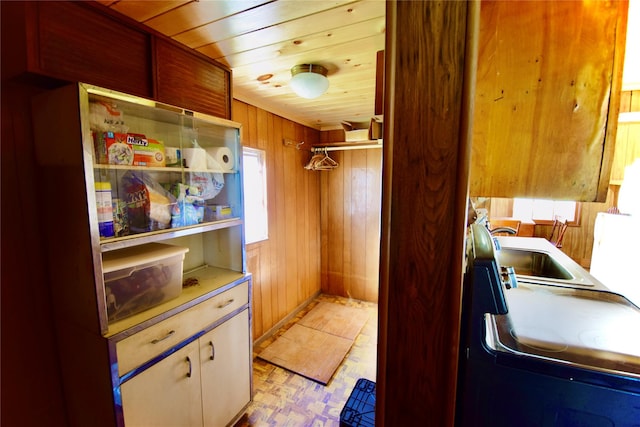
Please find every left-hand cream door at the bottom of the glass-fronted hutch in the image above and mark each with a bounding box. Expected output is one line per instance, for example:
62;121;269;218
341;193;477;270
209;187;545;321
121;341;202;427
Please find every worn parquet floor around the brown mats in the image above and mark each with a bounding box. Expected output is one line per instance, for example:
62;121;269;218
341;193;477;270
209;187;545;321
235;294;378;427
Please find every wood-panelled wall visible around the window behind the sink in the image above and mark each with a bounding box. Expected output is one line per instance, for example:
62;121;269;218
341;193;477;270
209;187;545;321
490;91;640;268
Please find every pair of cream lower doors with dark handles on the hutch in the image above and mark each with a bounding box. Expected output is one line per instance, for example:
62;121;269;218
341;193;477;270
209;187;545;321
121;310;251;427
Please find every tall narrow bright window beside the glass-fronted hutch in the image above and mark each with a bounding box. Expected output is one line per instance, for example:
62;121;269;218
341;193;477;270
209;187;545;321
242;147;269;244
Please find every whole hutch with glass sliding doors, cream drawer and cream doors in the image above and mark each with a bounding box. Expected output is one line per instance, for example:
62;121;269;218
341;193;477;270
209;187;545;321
32;83;251;426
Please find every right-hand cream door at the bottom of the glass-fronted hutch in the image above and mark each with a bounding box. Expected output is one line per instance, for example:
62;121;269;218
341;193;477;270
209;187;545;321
200;309;251;427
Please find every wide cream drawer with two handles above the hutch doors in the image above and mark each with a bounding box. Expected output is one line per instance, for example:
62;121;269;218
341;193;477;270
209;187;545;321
116;282;249;376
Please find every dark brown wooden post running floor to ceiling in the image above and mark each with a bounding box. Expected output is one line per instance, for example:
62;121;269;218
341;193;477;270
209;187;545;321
376;1;479;426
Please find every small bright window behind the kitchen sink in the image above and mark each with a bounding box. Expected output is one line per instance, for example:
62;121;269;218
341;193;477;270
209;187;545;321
512;199;580;225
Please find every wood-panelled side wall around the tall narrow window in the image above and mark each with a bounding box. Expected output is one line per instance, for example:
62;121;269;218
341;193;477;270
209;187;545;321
232;100;320;340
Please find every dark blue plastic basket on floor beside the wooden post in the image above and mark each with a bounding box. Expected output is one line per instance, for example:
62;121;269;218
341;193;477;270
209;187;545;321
340;378;376;427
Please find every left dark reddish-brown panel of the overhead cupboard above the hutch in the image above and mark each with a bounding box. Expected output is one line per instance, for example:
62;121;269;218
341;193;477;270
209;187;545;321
36;2;154;98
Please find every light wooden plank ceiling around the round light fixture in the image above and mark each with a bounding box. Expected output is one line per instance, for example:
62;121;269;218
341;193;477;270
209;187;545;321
100;0;385;130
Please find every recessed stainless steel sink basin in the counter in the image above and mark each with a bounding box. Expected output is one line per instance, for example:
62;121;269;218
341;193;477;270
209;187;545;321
498;248;574;280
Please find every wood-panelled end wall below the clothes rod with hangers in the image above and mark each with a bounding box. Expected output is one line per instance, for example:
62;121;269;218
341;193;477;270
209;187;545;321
317;148;382;302
